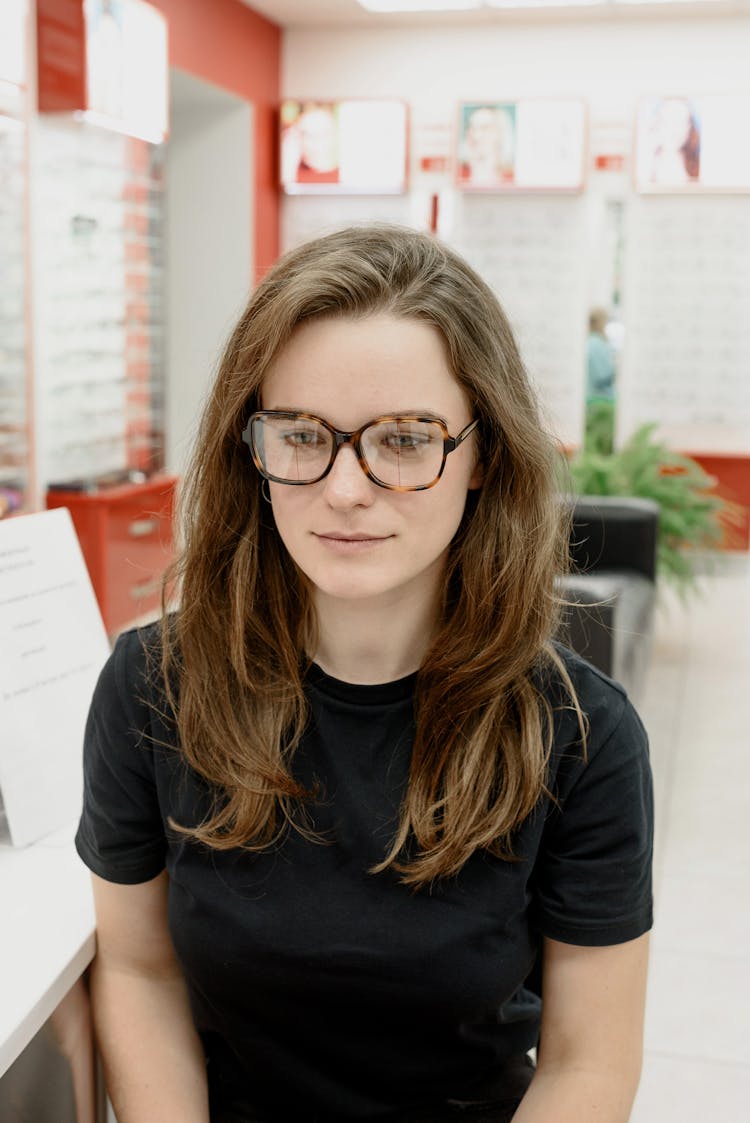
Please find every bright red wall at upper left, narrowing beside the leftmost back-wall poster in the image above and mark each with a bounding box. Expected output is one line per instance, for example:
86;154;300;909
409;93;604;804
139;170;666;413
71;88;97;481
150;0;282;276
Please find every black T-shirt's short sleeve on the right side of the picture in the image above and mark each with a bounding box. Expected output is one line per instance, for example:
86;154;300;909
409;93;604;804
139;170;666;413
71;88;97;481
536;682;653;947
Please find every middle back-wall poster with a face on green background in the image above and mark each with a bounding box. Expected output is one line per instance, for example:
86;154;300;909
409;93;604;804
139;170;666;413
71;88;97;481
456;98;586;192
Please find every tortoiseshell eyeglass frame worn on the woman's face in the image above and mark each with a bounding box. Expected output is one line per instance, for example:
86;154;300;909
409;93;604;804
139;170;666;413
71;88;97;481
243;410;479;492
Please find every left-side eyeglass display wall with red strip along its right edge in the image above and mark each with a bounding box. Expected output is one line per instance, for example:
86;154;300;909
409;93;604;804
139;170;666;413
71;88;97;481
35;117;165;486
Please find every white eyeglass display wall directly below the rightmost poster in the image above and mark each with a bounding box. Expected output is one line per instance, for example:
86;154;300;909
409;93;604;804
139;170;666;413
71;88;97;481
621;195;750;454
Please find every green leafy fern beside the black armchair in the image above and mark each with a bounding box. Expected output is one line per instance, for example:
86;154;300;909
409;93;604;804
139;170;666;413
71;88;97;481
568;422;737;594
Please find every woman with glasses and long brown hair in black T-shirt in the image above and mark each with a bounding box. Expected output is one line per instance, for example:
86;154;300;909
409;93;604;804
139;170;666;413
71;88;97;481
77;227;651;1123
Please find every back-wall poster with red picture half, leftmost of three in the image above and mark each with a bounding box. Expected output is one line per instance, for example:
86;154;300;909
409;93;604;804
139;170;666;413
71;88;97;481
280;99;408;194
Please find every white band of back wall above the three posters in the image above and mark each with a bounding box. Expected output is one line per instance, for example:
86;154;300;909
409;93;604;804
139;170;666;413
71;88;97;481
282;17;750;119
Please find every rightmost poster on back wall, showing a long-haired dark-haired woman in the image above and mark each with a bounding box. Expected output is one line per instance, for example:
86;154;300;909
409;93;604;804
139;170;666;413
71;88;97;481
635;95;750;193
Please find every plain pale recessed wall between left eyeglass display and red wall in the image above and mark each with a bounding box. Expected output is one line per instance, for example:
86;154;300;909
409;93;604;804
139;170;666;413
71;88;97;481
166;69;254;474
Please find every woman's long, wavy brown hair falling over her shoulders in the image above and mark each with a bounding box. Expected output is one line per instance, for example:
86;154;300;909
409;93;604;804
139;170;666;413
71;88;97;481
161;226;576;886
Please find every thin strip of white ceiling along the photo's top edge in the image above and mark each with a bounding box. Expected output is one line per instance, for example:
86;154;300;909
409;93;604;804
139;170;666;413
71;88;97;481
243;0;750;28
